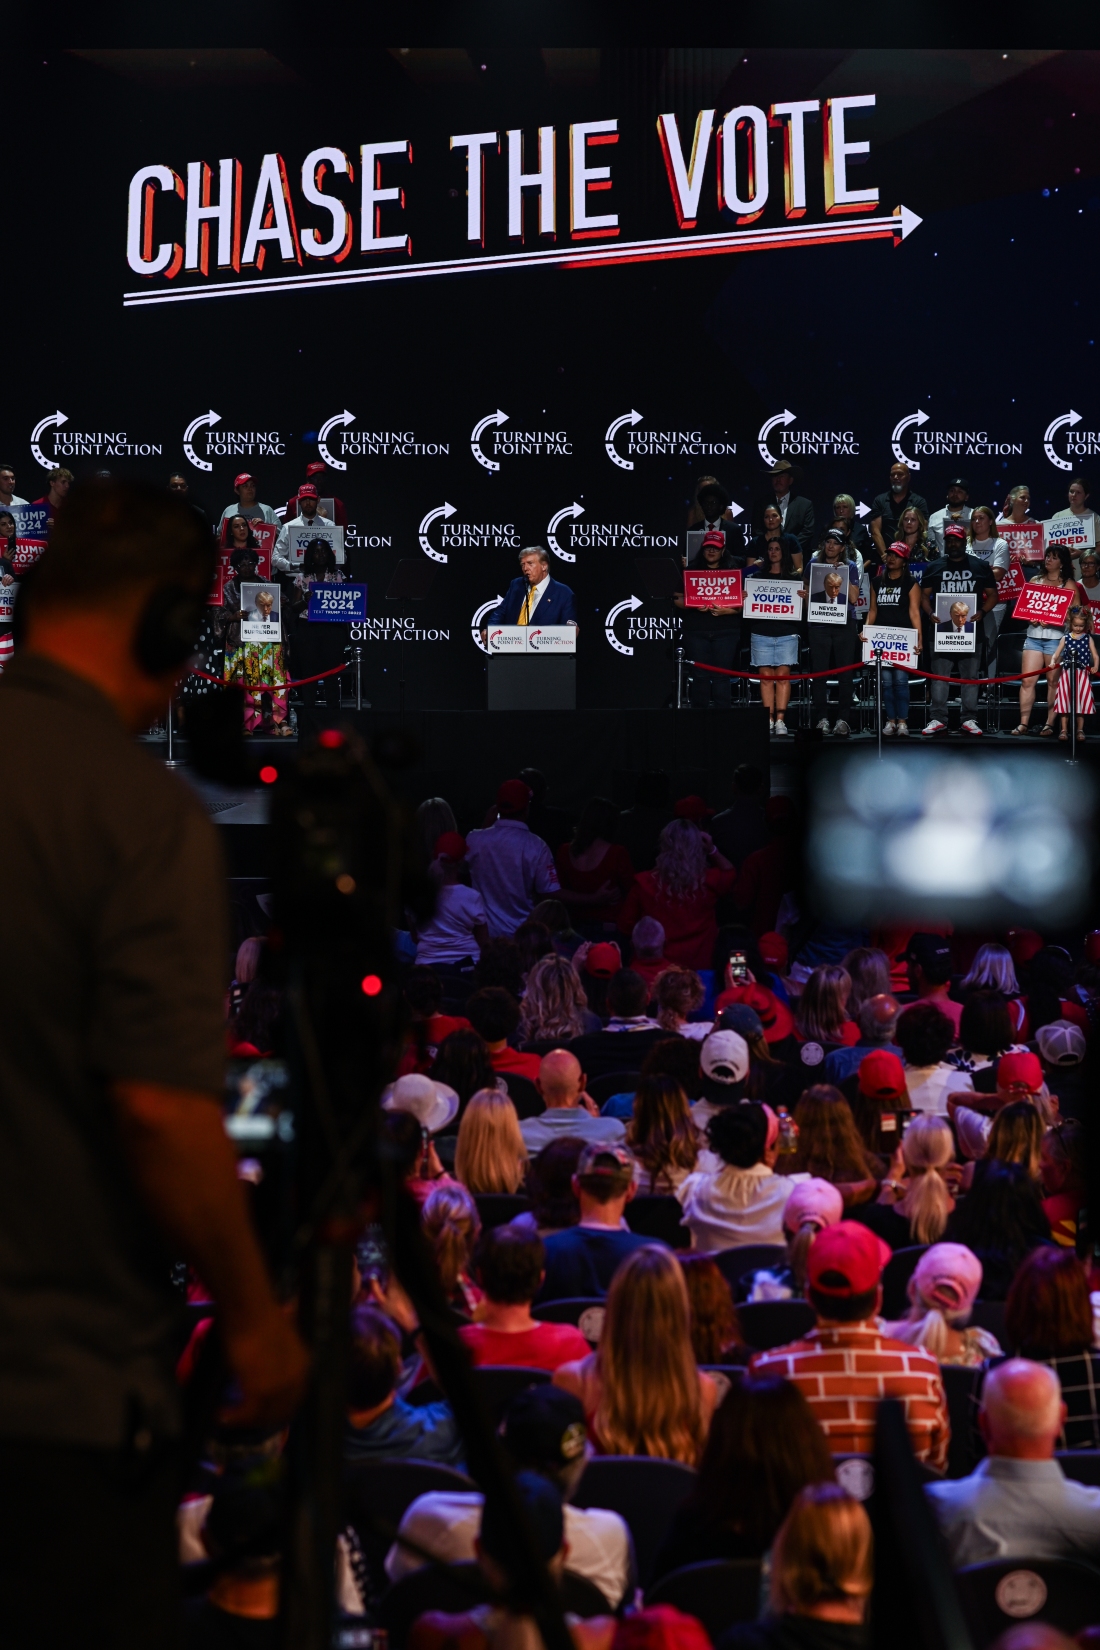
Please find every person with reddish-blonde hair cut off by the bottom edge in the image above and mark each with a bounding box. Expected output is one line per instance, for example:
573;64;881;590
717;1483;874;1650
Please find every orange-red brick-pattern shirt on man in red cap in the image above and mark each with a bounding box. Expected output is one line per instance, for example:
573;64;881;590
750;1323;952;1470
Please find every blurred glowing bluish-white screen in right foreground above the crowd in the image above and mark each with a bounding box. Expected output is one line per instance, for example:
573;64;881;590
806;749;1095;929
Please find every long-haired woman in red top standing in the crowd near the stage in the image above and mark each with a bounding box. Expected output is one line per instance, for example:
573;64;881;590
618;818;737;969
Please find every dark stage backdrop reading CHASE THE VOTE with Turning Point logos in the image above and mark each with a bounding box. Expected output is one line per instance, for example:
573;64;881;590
8;43;1100;708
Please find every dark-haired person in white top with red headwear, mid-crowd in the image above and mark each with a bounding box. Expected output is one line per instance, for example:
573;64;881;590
676;1095;805;1251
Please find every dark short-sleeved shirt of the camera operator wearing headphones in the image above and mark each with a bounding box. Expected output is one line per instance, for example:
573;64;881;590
0;653;226;1449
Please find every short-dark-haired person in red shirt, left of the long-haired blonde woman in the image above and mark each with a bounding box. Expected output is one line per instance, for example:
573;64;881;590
458;1226;589;1371
